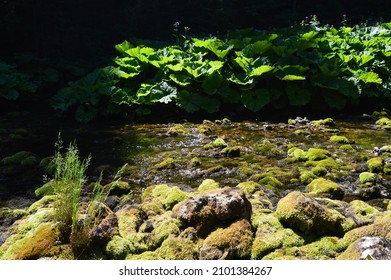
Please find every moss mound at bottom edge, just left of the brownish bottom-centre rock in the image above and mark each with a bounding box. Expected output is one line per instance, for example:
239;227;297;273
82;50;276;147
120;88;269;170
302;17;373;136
156;236;198;260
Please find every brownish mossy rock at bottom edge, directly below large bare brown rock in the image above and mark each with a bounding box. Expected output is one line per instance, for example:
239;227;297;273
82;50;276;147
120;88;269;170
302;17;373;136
200;220;253;260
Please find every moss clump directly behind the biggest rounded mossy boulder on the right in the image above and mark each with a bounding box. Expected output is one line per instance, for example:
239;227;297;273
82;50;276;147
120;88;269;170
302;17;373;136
307;178;344;199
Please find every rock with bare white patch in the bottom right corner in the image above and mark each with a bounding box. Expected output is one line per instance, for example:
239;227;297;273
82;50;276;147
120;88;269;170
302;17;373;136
337;236;391;260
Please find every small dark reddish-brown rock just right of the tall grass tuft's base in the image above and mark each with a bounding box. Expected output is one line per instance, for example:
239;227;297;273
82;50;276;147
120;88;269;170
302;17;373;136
90;213;118;245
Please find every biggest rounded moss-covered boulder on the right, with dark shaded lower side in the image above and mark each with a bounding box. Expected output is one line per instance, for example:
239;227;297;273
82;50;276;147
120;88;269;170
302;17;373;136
276;191;346;236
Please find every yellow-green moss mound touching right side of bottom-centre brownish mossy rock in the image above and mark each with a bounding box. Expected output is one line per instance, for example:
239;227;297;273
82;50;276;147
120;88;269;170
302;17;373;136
251;225;304;260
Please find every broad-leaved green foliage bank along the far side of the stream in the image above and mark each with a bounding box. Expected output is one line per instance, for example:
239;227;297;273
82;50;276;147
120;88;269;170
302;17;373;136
52;21;391;121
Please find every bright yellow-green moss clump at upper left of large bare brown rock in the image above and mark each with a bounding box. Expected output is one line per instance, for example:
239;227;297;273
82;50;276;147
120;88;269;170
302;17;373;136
152;185;189;210
